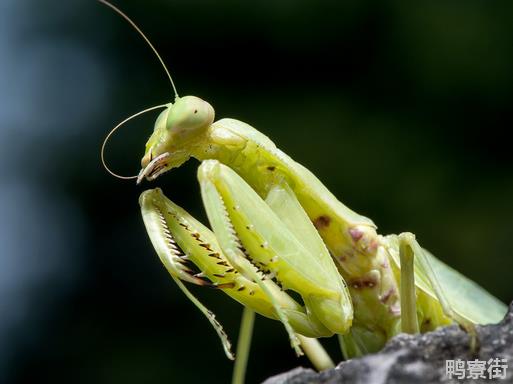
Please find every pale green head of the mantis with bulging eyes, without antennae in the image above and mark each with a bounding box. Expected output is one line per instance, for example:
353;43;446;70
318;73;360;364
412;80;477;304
137;96;215;183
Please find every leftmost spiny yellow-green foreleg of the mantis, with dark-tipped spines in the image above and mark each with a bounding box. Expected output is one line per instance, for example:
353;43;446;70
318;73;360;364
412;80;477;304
139;170;342;354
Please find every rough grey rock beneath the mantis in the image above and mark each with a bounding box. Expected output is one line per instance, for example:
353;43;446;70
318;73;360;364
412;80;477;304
263;303;513;384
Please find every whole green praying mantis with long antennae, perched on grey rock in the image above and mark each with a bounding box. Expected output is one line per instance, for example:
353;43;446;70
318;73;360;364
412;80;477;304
99;0;506;383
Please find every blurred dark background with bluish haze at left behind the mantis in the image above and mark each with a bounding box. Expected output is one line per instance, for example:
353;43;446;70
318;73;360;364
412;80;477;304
0;0;513;384
